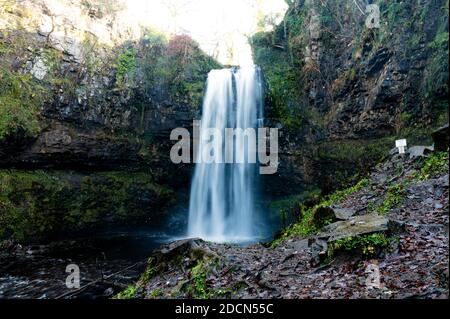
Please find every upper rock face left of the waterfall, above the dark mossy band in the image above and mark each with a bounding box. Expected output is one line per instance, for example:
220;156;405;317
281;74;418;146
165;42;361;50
0;0;218;171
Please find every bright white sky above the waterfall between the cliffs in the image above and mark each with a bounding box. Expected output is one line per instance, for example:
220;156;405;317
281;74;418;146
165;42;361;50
125;0;287;65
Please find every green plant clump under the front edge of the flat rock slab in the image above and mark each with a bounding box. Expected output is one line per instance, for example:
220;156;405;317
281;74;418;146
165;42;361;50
329;233;389;258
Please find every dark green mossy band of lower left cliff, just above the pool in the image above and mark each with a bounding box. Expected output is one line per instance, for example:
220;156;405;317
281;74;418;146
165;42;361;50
0;170;173;241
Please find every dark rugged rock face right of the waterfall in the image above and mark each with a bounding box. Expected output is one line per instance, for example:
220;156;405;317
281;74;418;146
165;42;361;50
252;0;448;196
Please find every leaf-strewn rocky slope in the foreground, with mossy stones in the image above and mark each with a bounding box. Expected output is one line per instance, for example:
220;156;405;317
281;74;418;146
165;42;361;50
116;142;449;298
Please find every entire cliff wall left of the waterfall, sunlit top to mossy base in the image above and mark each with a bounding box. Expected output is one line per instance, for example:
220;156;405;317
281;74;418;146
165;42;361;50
0;0;219;240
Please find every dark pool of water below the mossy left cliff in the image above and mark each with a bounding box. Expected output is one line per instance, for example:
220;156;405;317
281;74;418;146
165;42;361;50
0;230;173;299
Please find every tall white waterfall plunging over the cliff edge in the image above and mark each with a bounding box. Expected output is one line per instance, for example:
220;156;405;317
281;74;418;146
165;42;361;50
188;67;263;242
